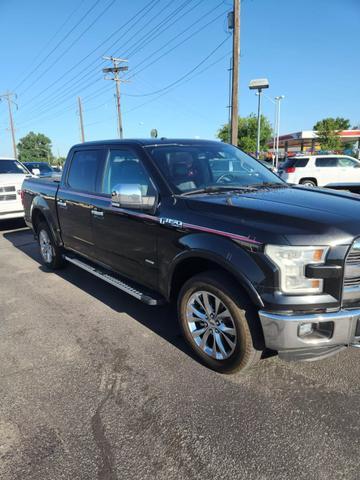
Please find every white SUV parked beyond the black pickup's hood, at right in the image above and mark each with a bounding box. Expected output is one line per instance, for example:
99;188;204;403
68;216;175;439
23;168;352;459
278;154;360;187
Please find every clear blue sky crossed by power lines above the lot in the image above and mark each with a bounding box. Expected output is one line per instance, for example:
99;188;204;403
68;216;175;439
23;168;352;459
0;0;360;156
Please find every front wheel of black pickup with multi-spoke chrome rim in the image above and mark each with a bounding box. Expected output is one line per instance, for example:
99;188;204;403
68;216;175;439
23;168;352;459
178;271;262;373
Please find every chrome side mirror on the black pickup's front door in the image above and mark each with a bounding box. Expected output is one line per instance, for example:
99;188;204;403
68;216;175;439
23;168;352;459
111;183;156;210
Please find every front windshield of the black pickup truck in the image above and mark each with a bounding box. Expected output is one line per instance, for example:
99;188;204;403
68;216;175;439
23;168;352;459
148;143;284;193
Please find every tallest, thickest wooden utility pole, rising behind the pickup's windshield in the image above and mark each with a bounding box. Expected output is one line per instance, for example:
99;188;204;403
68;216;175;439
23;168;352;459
231;0;240;145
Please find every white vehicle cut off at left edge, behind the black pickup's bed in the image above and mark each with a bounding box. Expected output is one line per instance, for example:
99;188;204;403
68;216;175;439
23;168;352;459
0;158;30;221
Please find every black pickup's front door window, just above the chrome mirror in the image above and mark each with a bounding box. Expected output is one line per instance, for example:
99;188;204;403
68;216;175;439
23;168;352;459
102;148;155;197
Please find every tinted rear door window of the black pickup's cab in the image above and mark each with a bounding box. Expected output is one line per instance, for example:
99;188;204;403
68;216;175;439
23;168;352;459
67;150;102;192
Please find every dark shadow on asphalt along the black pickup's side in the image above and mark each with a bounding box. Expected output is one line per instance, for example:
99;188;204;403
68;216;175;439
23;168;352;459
3;230;198;361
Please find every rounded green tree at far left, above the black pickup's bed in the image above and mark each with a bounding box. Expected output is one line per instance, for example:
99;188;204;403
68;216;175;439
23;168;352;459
17;132;53;163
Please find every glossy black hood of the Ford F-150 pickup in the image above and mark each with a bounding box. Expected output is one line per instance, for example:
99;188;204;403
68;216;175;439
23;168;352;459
186;186;360;245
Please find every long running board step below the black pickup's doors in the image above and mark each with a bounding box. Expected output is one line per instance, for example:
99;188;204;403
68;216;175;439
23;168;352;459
64;255;164;305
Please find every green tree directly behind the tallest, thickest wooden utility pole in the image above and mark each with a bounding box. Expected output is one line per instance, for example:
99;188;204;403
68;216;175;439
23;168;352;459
217;113;272;152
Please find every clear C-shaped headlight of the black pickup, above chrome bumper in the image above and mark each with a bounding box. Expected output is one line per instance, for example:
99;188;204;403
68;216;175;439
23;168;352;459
265;245;329;295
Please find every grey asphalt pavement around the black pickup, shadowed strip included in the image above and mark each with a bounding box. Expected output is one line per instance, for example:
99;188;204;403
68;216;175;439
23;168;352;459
0;219;360;480
